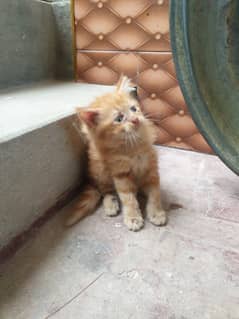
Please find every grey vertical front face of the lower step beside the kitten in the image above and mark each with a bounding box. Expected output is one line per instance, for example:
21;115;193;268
0;117;84;250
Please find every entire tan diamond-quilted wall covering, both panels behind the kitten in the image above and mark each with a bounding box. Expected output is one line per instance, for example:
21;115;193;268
74;0;212;153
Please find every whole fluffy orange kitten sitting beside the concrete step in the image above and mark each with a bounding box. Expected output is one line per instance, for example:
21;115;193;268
67;76;166;231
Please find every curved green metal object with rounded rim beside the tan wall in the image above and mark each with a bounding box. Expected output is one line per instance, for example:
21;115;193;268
170;0;239;175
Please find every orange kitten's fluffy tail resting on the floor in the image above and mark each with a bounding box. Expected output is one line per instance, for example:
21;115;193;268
65;185;101;226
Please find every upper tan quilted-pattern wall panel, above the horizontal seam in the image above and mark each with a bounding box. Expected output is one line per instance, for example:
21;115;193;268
74;0;170;51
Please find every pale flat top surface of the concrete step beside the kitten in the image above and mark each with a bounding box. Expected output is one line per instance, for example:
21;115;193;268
0;81;112;143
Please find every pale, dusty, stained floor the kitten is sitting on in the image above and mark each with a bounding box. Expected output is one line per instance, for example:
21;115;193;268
0;148;239;319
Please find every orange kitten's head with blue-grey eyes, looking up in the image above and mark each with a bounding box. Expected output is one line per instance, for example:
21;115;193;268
77;76;155;148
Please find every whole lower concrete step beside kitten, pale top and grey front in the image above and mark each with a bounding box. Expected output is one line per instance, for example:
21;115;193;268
0;81;114;255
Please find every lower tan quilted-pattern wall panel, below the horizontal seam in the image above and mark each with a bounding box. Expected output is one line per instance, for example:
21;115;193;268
77;51;211;153
